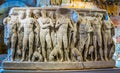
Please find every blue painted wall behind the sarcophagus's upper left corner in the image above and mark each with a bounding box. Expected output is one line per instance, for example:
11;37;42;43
0;0;50;25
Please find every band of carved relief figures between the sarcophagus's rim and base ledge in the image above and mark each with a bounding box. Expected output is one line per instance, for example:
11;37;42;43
3;7;115;62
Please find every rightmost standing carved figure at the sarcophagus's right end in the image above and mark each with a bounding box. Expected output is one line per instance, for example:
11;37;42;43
103;19;114;61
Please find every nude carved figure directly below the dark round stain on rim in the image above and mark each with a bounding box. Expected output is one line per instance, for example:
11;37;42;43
55;15;74;61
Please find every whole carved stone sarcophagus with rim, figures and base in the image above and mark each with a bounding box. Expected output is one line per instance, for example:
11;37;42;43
3;8;115;70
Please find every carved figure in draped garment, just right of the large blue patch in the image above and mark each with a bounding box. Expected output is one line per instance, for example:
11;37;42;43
78;17;93;61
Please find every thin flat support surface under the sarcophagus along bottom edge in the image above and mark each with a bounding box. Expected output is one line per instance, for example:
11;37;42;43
2;68;120;73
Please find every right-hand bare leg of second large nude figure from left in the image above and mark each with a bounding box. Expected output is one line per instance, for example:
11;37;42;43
28;32;34;61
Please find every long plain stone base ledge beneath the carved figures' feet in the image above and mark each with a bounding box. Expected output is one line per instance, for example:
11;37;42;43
3;61;115;70
